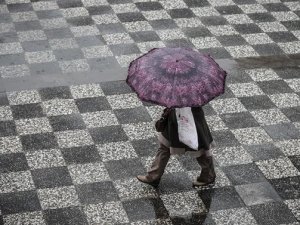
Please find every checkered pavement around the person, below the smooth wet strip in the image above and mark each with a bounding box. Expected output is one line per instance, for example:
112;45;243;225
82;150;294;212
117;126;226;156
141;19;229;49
0;66;300;225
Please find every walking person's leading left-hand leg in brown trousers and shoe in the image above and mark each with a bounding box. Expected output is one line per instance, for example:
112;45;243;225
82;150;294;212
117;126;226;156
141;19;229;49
137;144;170;187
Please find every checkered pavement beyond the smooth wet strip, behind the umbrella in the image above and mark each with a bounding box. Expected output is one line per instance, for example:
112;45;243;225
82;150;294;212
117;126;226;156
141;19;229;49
0;0;300;78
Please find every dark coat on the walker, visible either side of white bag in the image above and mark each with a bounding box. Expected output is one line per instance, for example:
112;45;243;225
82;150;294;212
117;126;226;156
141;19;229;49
162;107;213;150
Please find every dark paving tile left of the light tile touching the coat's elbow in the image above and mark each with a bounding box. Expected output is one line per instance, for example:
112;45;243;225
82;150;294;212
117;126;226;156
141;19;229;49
90;126;128;143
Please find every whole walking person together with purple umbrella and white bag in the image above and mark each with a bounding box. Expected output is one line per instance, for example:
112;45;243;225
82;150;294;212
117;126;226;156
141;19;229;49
126;48;227;187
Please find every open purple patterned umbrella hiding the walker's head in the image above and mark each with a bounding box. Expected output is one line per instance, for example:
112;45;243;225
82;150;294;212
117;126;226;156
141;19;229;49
126;48;226;108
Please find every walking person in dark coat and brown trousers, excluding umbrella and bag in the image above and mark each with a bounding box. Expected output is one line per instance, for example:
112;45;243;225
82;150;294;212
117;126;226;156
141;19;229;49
137;107;216;188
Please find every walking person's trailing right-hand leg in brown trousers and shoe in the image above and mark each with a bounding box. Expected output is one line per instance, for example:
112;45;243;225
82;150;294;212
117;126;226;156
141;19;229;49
193;154;216;187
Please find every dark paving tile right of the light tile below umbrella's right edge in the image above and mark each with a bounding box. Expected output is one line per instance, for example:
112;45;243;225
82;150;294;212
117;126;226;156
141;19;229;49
239;95;276;110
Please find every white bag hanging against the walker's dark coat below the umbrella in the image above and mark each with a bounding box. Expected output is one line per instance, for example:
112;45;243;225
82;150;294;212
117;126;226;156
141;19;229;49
175;107;199;150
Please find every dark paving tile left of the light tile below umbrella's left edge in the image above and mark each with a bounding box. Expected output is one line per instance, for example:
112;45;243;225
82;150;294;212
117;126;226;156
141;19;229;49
75;96;111;113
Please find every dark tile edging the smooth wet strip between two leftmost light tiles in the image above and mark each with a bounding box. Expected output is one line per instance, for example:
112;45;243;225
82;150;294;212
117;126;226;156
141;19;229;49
39;86;72;101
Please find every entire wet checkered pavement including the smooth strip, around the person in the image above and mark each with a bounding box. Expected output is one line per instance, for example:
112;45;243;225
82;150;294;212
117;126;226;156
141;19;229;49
0;0;300;225
